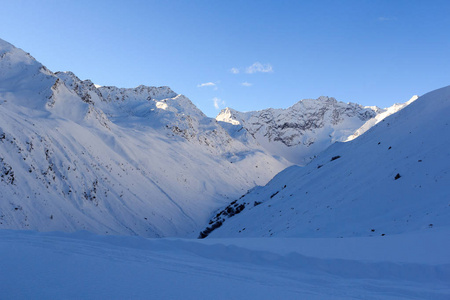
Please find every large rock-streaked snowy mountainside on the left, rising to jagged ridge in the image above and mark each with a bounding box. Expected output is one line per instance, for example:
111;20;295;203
0;40;289;237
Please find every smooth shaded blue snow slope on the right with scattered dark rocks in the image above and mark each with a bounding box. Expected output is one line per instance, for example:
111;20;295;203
201;86;450;237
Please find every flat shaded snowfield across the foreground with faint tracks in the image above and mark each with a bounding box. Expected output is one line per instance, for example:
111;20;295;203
0;230;450;299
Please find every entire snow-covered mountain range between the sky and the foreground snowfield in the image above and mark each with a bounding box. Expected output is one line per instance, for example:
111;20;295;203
0;40;450;241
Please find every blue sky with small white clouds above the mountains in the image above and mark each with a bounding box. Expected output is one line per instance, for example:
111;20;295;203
0;0;450;117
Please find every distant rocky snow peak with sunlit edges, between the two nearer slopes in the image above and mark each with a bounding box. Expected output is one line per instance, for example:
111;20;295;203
216;96;417;165
